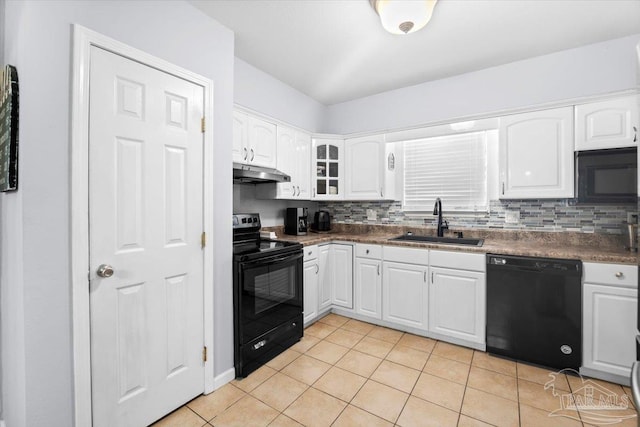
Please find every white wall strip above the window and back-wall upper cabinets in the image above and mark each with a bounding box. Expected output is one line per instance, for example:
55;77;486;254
323;34;640;134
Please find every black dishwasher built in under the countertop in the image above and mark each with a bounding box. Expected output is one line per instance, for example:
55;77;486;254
487;254;582;370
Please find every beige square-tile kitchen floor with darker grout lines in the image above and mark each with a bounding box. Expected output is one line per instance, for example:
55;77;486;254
154;314;637;427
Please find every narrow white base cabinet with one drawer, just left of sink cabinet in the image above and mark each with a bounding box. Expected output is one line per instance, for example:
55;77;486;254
354;244;382;319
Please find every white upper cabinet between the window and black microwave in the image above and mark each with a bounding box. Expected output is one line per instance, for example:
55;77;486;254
499;107;574;199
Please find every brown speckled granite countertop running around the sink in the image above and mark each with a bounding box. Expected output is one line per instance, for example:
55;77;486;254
265;224;637;264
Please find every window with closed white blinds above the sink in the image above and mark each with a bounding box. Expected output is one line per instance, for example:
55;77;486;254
402;132;488;212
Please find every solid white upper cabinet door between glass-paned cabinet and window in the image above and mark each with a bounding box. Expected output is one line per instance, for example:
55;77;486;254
344;135;384;200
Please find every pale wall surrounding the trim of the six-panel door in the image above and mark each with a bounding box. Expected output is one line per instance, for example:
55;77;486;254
0;0;233;427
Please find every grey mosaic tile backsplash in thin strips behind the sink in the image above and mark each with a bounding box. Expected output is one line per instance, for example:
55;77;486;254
319;199;638;234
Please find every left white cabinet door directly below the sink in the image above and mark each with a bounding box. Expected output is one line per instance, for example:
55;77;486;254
382;261;429;331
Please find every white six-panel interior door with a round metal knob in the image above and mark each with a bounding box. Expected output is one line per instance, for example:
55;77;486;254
89;47;204;426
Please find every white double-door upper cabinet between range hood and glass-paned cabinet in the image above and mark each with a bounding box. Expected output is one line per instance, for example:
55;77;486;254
272;126;311;200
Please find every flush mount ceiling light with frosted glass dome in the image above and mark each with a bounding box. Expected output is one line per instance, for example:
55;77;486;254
369;0;438;34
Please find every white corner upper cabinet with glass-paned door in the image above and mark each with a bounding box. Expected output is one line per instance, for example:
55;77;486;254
311;138;344;200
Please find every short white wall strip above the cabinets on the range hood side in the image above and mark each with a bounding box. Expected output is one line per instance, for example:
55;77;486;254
234;58;326;132
